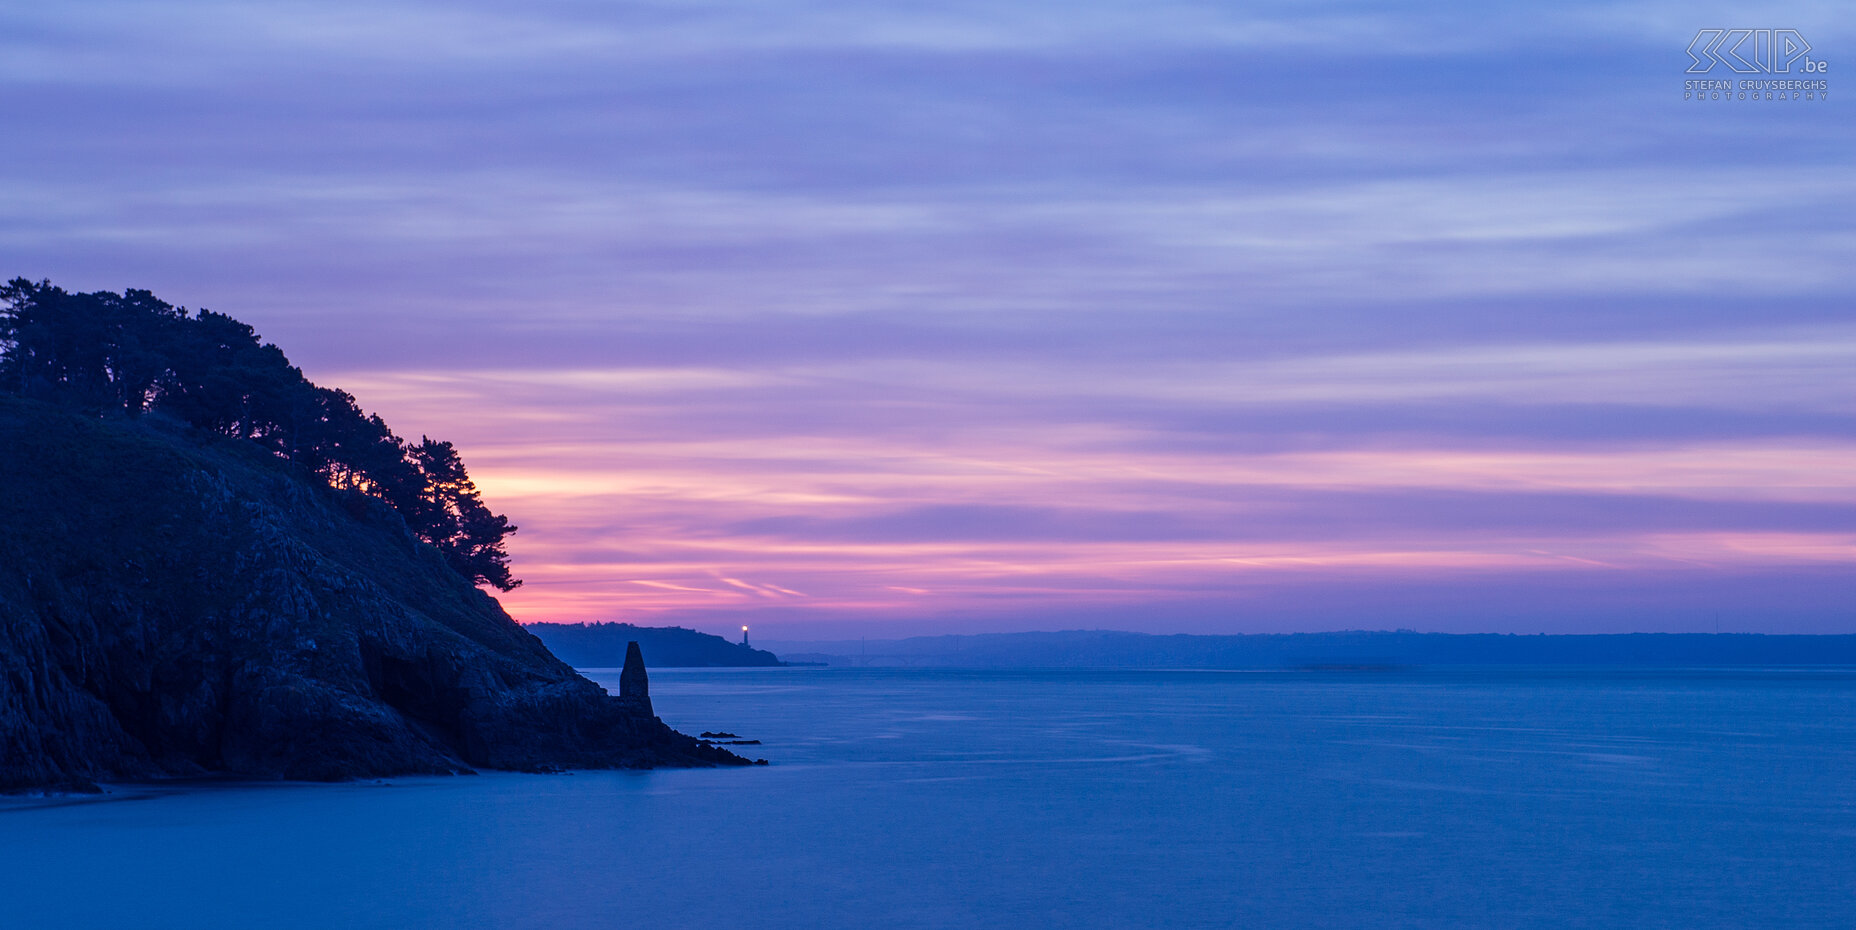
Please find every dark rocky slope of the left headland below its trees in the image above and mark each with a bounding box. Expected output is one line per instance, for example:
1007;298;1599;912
0;397;744;789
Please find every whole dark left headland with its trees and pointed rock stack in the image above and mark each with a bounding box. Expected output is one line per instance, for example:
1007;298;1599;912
0;280;748;791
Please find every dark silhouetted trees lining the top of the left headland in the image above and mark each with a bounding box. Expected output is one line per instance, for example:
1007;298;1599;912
0;278;522;590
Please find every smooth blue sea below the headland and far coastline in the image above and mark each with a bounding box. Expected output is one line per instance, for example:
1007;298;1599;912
0;668;1856;930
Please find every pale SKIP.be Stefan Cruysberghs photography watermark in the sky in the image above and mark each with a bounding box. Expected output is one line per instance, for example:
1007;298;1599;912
1682;30;1830;100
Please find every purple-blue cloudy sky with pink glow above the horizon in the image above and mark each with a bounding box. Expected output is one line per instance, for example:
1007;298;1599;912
0;0;1856;639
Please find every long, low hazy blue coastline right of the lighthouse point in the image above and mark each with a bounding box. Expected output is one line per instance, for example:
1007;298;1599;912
767;629;1856;670
